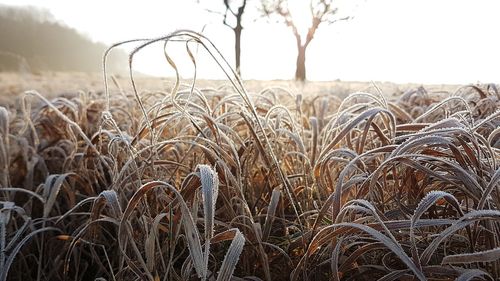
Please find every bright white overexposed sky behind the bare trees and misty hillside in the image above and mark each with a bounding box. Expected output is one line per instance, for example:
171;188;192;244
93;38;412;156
0;0;500;83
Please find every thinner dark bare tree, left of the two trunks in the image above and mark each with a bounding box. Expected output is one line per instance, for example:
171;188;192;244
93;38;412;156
203;0;247;76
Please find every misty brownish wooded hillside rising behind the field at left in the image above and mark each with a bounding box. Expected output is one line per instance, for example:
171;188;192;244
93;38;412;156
0;5;127;73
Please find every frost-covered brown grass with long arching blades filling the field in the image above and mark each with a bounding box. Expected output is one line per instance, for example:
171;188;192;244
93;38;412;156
0;31;500;281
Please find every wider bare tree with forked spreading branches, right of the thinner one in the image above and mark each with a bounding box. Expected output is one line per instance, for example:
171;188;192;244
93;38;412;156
262;0;349;81
